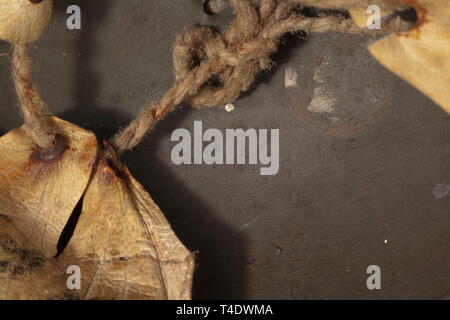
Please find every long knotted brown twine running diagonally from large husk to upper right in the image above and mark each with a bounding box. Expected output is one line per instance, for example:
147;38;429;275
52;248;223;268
111;0;410;154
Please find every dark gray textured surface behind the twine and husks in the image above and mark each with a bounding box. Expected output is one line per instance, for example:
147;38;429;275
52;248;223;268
0;0;450;299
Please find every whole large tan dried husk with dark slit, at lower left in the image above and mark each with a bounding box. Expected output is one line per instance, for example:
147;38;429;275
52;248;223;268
0;118;194;299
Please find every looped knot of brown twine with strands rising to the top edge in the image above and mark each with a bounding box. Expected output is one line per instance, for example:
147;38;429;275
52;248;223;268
173;0;284;108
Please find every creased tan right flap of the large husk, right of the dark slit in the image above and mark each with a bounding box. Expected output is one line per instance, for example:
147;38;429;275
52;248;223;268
57;150;194;300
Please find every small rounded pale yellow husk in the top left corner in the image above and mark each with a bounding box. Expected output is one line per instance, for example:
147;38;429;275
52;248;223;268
0;0;53;44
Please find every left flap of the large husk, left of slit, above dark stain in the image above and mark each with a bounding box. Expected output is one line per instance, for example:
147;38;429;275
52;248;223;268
0;118;97;257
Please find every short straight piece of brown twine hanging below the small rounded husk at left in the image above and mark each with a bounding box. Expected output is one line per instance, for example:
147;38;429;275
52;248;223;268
12;44;55;149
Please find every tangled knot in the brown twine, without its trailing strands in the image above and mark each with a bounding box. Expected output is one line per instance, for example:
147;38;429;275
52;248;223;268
173;28;278;108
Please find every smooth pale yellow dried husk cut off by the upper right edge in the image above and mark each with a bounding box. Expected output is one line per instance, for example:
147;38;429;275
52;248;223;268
369;0;450;113
